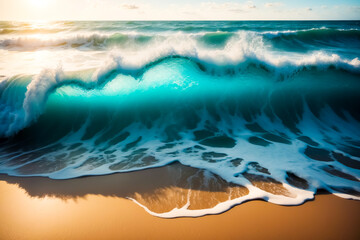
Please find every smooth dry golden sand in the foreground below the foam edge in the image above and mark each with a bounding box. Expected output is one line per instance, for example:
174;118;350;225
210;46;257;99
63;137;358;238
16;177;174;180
0;181;360;240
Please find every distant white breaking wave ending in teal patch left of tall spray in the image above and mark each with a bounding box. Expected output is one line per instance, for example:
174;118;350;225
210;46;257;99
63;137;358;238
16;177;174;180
0;32;245;51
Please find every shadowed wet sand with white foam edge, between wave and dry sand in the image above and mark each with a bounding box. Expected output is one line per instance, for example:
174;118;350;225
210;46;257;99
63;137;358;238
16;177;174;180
0;162;314;218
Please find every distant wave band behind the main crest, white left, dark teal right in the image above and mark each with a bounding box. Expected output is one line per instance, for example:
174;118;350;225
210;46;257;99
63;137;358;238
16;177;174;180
0;28;360;51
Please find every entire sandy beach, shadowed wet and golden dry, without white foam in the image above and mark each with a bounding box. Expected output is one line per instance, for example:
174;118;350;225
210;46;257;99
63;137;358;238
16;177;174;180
0;166;360;239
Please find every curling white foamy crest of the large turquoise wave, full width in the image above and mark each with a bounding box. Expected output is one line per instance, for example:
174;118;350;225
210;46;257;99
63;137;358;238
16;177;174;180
1;45;360;136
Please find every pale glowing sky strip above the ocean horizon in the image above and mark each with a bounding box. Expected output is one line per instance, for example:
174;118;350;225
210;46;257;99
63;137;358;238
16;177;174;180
0;0;360;21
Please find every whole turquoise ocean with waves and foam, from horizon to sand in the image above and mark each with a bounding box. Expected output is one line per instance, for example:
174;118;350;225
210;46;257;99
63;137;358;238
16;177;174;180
0;21;360;217
